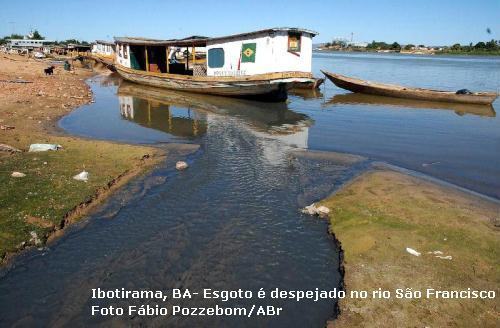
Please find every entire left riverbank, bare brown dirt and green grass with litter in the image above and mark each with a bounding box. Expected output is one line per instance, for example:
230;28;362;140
0;54;165;263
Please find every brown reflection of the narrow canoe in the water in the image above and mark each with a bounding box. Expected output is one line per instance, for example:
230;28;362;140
323;93;496;117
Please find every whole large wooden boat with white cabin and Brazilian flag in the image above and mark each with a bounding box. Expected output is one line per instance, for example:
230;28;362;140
115;28;317;101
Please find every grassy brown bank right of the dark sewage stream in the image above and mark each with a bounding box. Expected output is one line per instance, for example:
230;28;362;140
320;170;500;328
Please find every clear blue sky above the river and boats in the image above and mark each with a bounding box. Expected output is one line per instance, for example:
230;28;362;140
0;0;500;45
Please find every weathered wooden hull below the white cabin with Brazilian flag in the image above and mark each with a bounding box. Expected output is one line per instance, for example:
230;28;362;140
116;65;313;101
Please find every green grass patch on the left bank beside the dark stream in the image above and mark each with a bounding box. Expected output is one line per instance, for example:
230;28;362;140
0;137;162;258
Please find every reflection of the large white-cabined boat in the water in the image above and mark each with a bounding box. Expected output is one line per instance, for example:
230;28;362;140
118;82;313;165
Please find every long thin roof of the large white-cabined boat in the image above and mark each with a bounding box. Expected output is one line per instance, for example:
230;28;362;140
114;27;318;46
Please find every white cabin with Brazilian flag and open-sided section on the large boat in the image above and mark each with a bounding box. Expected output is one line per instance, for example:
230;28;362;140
115;28;317;77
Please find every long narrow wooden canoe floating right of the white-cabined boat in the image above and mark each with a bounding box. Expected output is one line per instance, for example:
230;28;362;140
322;71;497;105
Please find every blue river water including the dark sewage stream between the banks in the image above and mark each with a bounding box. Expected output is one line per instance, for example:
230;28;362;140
0;53;500;327
